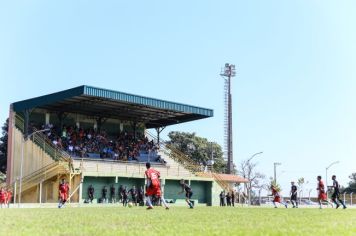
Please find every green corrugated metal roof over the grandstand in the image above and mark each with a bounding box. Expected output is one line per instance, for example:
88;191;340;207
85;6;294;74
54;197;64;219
13;85;213;128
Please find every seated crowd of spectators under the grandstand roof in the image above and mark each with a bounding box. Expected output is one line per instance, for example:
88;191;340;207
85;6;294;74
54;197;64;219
34;124;165;163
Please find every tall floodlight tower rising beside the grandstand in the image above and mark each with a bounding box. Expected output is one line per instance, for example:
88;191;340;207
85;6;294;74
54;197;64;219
220;63;236;174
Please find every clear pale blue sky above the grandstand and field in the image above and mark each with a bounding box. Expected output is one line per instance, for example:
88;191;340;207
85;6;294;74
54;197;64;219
0;0;356;195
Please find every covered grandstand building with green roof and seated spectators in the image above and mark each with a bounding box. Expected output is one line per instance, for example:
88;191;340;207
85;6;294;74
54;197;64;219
7;85;247;206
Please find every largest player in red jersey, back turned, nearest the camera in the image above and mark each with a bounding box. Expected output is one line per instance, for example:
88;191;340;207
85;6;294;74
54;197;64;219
145;162;169;210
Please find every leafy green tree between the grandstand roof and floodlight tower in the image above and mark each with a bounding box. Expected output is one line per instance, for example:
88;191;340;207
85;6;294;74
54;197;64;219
168;131;226;173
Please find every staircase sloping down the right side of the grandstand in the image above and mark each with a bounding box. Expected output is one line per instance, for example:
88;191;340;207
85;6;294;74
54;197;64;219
146;131;232;191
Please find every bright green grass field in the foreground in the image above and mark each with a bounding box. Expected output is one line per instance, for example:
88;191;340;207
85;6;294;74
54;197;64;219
0;207;356;236
